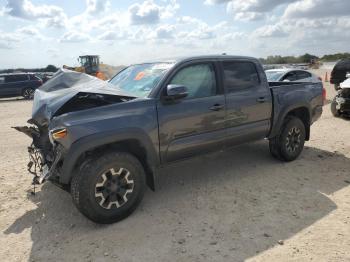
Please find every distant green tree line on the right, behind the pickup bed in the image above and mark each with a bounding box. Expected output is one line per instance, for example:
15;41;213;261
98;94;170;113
260;53;350;64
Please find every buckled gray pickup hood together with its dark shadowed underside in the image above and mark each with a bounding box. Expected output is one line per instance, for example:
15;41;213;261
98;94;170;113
31;69;135;126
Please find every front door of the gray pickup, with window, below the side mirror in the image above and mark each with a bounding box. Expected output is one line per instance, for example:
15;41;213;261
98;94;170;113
157;61;225;163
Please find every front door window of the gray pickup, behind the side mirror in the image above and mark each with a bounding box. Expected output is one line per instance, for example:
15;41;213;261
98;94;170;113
169;64;216;98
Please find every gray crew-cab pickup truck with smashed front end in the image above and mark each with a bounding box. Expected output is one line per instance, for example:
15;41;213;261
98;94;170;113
16;55;325;223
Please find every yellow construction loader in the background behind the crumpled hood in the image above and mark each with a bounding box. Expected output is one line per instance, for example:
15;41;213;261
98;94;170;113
63;55;107;80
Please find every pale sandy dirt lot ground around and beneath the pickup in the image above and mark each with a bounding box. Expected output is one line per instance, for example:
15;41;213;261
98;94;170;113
0;72;350;261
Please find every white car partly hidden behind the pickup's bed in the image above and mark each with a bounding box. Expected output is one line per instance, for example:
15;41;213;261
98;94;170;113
265;68;322;83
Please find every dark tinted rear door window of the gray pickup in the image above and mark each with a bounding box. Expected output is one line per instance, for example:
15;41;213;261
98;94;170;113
223;62;260;93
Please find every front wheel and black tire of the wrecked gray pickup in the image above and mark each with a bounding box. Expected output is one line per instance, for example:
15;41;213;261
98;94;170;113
71;152;145;224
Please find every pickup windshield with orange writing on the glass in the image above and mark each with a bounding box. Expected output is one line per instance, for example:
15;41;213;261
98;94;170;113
109;63;174;97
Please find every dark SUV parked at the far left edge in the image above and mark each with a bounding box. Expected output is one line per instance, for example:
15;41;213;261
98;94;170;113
0;73;43;99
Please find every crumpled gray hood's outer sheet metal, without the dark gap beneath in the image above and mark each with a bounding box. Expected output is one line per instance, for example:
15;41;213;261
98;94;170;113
31;69;134;126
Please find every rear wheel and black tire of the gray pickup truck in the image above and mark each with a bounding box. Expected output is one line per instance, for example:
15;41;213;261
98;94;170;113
269;116;306;162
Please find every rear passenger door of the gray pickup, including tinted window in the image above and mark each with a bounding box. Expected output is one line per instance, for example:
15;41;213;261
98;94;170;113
222;60;272;146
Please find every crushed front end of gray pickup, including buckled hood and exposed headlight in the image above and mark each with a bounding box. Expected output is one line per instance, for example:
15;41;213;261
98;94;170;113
14;70;135;189
